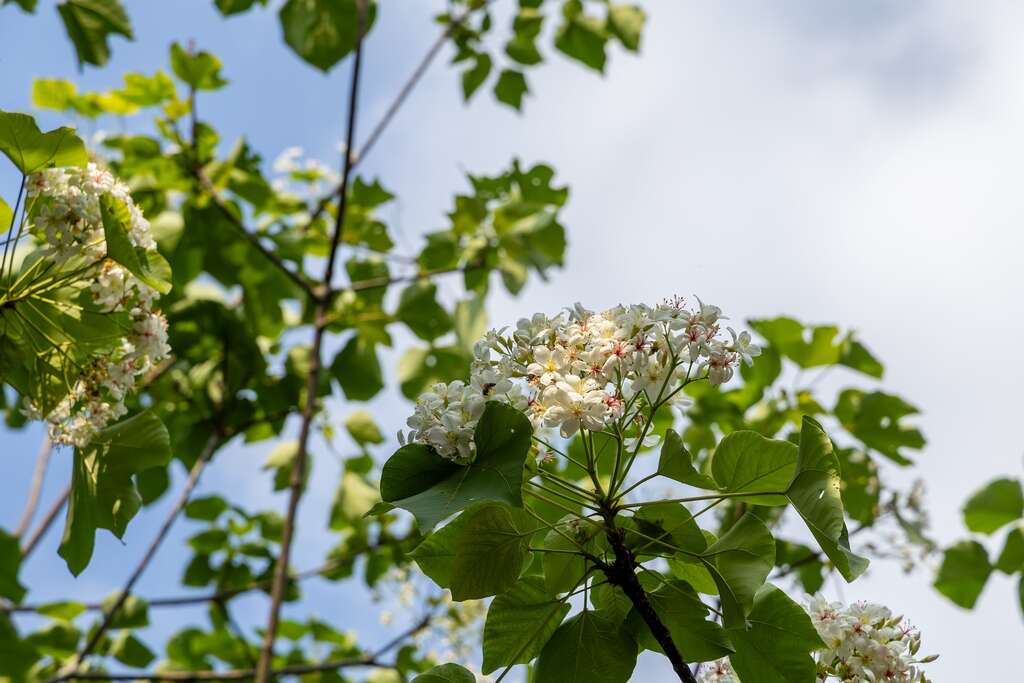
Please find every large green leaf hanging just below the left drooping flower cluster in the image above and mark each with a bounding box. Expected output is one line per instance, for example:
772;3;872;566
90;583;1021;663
57;411;171;577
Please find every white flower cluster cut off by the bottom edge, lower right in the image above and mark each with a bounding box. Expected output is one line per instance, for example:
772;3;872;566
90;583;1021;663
807;595;935;683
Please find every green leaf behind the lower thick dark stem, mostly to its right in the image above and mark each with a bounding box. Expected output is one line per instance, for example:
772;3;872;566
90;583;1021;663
627;581;732;663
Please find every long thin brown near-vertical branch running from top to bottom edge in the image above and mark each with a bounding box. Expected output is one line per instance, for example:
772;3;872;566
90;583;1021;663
255;5;367;683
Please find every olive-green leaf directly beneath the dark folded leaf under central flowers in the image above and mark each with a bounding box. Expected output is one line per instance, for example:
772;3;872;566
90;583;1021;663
452;505;536;601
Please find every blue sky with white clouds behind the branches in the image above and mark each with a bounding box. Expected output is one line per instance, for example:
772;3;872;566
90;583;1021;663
0;0;1024;680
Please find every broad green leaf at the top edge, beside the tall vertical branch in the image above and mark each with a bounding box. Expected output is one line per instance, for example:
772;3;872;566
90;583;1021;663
280;0;377;72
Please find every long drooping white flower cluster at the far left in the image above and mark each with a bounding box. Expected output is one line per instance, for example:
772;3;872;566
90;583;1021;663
28;163;170;446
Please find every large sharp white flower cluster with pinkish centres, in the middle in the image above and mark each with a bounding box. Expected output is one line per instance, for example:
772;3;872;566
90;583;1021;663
408;298;761;464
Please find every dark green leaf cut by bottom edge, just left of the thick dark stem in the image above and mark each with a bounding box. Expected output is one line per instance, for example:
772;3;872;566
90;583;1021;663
532;610;637;683
